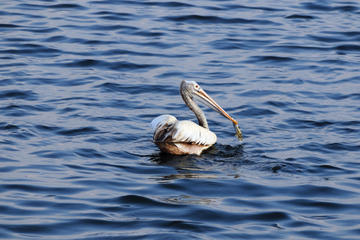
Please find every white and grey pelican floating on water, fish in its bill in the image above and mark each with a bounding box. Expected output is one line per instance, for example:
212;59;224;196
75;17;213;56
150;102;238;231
151;80;242;155
